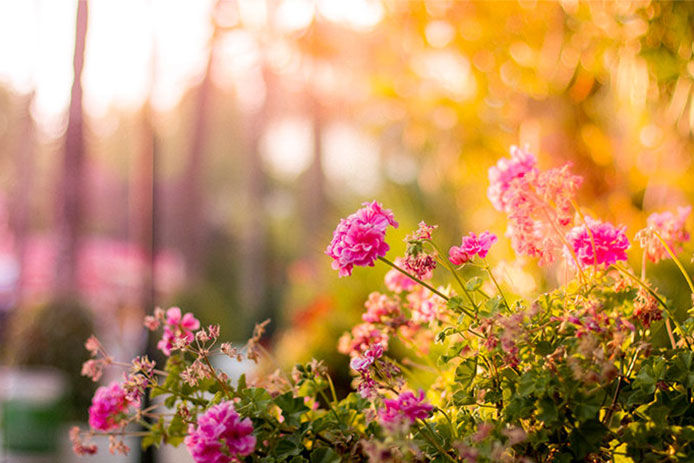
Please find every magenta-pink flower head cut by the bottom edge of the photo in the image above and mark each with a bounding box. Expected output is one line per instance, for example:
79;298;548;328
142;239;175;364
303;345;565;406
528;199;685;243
184;401;256;463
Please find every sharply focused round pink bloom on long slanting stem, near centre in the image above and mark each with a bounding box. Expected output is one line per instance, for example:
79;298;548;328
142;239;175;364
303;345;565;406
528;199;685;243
325;201;398;277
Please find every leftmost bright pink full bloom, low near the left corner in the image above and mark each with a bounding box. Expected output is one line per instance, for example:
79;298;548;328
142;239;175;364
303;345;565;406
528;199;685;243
89;381;140;431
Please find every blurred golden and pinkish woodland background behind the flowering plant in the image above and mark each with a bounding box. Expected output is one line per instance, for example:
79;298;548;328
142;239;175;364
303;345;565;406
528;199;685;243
0;0;694;461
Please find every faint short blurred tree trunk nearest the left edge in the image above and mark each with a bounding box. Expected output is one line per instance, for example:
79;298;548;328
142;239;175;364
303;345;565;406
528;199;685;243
10;91;35;306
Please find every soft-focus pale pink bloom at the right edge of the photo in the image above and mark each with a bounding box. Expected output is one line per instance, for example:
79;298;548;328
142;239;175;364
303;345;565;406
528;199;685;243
636;206;692;262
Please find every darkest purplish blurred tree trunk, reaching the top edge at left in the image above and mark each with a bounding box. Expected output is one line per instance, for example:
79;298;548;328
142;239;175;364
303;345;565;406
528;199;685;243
55;0;88;295
